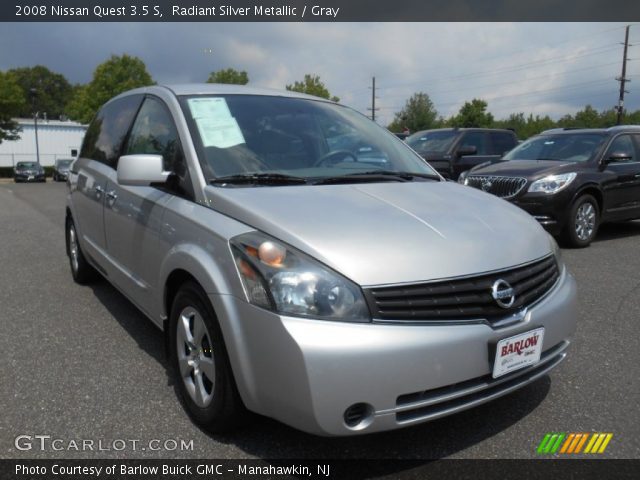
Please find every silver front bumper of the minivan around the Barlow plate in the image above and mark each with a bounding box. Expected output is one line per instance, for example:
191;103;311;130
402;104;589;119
210;268;577;435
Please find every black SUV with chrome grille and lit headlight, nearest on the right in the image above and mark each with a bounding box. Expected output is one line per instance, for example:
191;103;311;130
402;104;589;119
458;126;640;247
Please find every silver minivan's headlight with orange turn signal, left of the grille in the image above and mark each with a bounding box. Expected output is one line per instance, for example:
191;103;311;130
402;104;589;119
231;232;371;322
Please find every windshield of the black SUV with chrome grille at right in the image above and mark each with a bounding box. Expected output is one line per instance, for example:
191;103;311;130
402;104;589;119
503;133;605;162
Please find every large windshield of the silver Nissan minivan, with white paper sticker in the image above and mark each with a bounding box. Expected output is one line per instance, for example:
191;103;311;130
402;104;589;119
181;95;437;183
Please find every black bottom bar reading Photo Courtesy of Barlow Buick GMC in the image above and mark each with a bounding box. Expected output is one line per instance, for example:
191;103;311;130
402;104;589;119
0;459;640;480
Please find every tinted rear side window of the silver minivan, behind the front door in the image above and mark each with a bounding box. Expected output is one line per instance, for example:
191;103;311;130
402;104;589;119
80;95;142;169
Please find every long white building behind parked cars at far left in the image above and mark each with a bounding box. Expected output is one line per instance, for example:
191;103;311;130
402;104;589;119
0;118;87;167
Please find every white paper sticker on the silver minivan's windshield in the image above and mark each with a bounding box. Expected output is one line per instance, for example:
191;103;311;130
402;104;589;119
187;98;245;148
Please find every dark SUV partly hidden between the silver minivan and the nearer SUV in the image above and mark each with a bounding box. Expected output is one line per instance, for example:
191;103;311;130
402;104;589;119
405;128;518;180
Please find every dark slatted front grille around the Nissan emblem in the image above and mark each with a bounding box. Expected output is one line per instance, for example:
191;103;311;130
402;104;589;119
364;255;560;323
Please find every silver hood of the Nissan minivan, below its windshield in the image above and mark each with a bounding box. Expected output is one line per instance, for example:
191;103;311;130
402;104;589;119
206;182;551;285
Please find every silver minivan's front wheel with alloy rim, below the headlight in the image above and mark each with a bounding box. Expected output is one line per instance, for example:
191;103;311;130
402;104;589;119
169;282;248;433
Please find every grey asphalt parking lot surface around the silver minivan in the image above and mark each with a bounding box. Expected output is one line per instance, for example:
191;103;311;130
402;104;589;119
0;181;640;459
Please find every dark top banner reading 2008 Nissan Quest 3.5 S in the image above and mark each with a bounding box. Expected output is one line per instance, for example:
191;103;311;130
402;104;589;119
0;0;640;22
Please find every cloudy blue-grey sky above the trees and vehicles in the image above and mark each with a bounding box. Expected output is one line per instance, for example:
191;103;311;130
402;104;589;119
0;22;640;125
